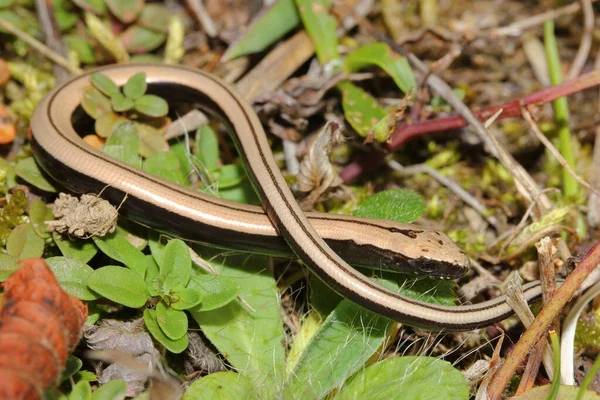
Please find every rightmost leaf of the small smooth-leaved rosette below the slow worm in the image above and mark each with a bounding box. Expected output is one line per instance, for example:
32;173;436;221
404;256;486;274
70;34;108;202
188;274;240;311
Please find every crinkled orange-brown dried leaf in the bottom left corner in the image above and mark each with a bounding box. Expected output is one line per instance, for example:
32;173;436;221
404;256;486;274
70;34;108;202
0;258;87;399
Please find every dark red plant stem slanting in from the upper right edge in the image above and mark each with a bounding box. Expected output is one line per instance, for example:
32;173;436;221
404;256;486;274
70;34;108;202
340;70;600;183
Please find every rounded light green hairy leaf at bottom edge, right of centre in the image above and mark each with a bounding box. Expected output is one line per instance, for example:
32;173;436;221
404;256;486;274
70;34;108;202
334;356;468;400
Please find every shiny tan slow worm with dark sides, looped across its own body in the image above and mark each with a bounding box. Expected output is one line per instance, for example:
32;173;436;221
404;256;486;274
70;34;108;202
31;64;540;331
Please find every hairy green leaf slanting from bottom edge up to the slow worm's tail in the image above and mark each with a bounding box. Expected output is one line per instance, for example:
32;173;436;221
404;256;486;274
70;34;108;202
280;294;391;399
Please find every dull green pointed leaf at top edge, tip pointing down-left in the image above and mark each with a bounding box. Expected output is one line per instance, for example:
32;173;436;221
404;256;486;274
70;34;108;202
223;0;300;61
